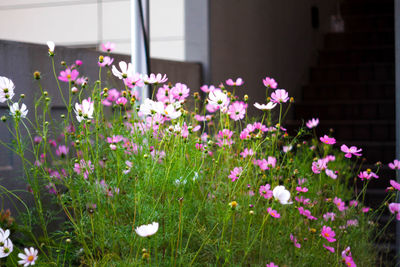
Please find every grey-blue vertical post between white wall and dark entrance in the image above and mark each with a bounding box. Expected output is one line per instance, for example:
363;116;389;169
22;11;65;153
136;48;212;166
185;0;211;84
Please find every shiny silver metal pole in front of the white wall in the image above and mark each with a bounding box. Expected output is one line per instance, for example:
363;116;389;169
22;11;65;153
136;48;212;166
130;0;150;101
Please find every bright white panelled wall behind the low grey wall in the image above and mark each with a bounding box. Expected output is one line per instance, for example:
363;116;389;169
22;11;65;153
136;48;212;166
0;0;185;60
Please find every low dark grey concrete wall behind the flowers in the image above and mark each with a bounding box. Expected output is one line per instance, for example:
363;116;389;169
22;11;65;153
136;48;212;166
0;40;203;215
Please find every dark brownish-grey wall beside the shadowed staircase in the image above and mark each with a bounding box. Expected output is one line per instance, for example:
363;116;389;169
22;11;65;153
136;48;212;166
210;0;336;116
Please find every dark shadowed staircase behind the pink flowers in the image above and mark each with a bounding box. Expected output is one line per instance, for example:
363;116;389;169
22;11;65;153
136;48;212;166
294;0;396;266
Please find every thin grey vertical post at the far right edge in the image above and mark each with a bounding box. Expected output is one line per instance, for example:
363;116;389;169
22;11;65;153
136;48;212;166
394;0;400;266
